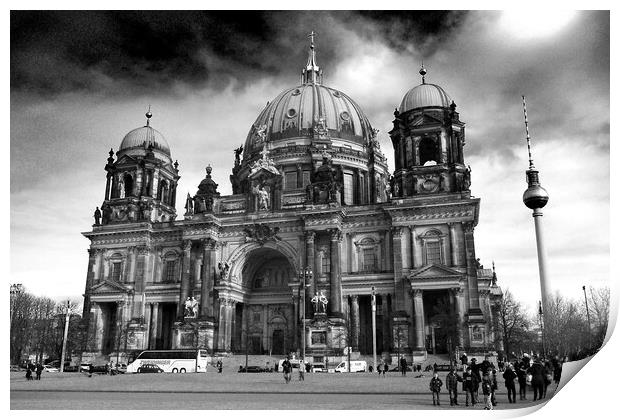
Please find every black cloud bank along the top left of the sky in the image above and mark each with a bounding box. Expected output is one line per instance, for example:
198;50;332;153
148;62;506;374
11;11;461;95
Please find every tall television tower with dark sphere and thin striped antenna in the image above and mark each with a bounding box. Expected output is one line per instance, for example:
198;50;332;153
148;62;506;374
522;96;549;322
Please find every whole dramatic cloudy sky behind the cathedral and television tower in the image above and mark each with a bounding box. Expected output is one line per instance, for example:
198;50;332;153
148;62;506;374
10;11;610;314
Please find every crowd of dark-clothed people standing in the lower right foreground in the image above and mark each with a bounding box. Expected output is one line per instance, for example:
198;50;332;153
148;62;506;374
429;353;562;410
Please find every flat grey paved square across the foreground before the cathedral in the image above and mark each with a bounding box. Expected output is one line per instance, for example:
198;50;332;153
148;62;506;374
10;370;555;410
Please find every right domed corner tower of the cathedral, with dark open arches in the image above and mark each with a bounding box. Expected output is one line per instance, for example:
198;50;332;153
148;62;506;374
389;66;470;198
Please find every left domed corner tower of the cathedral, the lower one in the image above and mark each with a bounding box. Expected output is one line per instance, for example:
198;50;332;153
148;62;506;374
101;108;180;225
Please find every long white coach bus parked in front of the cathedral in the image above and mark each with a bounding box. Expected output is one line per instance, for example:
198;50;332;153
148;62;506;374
127;349;211;373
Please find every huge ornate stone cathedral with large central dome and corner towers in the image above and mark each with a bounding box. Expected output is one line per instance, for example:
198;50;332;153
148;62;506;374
82;37;502;362
